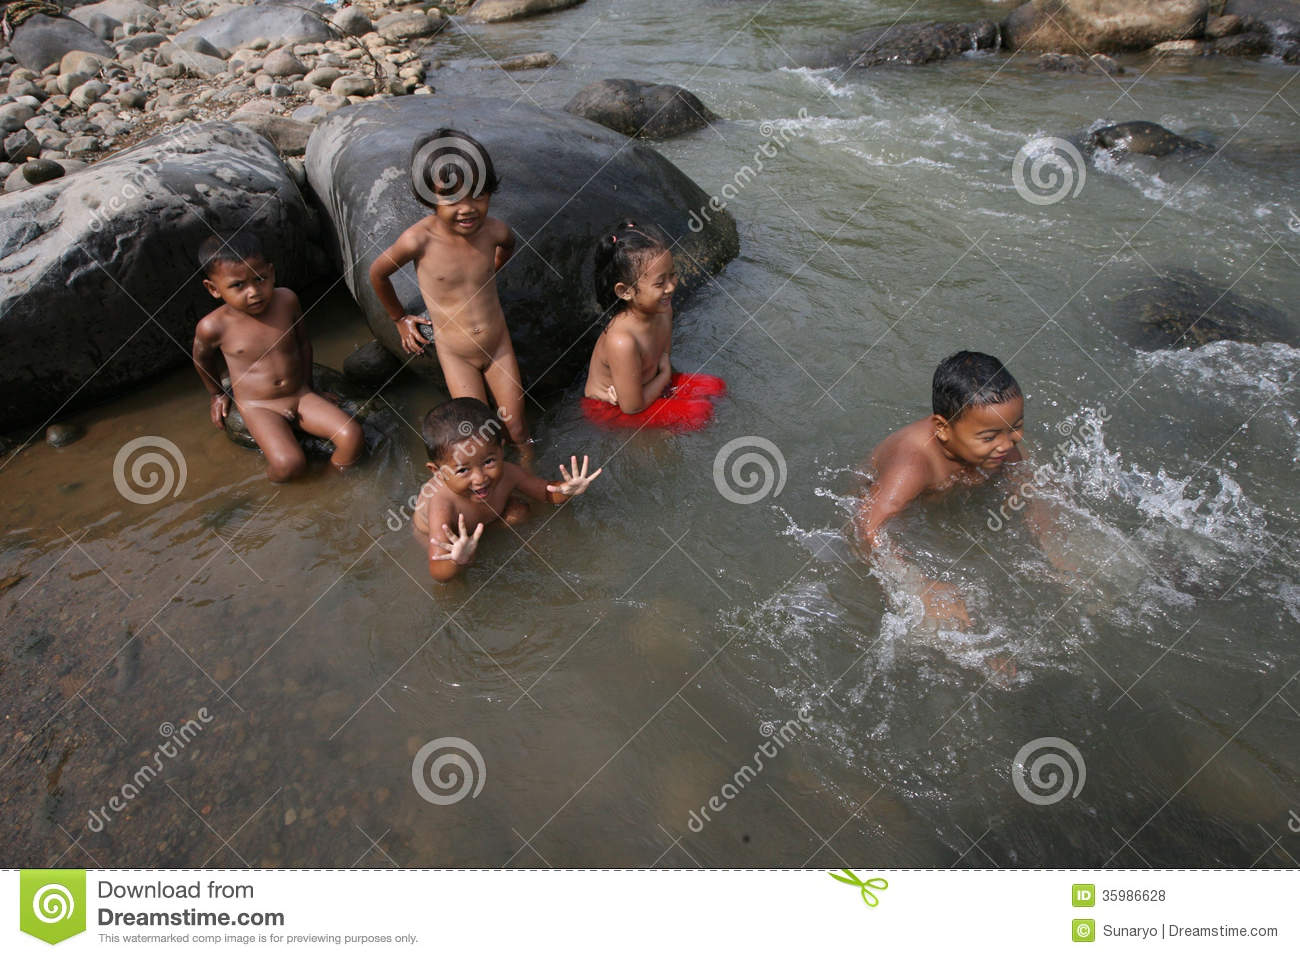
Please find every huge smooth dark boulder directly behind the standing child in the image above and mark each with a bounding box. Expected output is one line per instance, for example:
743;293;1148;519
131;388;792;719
299;96;740;395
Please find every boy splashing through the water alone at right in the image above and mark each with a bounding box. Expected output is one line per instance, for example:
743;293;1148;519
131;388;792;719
857;351;1024;627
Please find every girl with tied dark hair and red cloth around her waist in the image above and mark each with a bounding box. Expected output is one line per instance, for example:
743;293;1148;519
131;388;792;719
582;220;727;430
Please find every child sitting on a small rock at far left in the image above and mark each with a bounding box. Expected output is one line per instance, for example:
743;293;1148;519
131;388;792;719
194;233;364;482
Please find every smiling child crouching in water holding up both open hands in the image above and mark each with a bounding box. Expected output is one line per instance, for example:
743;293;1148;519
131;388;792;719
413;396;603;582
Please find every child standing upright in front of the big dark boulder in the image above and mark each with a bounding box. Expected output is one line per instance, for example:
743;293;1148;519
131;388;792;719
371;129;528;455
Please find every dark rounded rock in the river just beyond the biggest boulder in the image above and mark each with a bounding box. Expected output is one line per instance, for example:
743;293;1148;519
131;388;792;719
564;79;718;139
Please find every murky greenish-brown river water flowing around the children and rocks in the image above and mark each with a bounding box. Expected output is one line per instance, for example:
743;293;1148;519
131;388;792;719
0;0;1300;867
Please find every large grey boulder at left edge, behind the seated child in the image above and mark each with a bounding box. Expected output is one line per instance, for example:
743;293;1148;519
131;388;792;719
0;122;321;429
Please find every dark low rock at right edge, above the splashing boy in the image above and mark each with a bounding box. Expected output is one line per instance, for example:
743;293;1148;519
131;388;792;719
1109;269;1297;350
